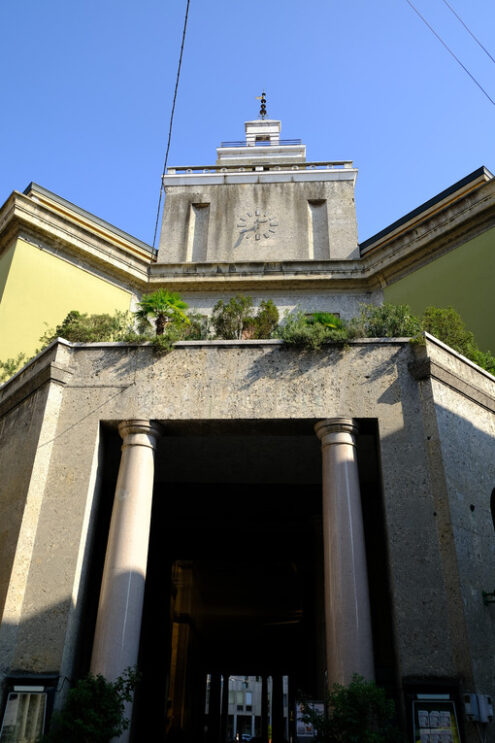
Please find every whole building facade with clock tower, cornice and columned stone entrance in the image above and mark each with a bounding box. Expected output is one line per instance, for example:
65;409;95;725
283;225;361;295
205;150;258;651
0;119;495;743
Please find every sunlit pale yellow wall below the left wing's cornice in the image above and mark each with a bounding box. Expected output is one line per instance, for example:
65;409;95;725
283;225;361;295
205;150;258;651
0;240;131;361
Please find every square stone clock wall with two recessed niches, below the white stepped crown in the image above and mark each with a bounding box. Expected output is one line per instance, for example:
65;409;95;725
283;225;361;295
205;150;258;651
158;177;359;264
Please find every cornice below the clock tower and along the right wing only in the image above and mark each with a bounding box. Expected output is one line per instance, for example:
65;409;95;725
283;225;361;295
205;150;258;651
149;177;495;292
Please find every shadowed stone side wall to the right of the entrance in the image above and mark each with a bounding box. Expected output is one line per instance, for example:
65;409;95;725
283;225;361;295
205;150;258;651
380;384;495;693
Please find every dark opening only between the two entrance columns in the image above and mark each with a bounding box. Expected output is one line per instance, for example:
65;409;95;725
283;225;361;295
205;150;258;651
141;421;324;743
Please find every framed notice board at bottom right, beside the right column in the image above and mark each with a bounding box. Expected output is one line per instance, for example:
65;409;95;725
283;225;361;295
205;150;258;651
412;699;461;743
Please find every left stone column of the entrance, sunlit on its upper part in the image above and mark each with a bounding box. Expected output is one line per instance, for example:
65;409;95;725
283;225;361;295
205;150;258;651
91;420;160;741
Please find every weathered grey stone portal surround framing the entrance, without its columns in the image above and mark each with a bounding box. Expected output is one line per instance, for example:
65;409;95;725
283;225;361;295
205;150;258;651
0;338;495;728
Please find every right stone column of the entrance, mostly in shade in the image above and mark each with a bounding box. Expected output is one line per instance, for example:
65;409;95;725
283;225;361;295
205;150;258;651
315;418;374;687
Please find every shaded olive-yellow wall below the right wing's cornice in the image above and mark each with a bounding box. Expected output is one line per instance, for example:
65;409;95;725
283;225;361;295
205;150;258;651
384;229;495;352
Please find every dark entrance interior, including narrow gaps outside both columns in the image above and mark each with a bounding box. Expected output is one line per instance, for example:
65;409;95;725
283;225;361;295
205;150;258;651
85;420;394;743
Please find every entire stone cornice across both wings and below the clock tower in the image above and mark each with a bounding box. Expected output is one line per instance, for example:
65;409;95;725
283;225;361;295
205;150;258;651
0;171;495;293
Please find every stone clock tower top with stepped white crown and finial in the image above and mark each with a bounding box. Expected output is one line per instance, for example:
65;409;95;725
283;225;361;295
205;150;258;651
157;107;359;270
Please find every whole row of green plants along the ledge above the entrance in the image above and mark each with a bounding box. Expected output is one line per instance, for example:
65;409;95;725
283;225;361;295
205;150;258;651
0;296;495;383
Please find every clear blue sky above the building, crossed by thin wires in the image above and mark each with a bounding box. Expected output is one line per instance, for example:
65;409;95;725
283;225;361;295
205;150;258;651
0;0;495;243
